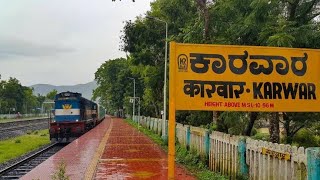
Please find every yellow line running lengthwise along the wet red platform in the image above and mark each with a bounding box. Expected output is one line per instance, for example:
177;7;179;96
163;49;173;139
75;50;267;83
84;118;113;179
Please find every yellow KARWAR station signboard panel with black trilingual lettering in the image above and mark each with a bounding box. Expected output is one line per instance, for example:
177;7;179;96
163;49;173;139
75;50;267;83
170;42;320;112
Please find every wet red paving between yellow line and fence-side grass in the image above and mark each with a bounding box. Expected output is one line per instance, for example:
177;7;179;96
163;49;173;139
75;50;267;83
94;119;195;180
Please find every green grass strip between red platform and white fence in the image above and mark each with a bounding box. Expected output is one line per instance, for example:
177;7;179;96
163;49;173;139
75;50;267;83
126;119;228;180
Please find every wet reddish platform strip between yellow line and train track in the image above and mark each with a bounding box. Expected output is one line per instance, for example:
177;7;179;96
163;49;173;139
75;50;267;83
21;116;111;180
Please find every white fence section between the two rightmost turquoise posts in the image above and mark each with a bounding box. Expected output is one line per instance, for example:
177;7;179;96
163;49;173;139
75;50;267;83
246;138;308;180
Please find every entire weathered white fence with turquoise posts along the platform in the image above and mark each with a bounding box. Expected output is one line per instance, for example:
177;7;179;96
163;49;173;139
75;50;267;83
135;117;320;180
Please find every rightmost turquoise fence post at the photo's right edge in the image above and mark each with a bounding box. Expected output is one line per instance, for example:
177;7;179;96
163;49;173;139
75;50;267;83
307;147;320;180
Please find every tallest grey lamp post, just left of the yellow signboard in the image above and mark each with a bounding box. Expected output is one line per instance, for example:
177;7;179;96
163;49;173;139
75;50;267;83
146;16;168;140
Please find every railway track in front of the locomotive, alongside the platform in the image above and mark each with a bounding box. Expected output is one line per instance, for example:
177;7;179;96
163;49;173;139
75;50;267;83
0;143;66;180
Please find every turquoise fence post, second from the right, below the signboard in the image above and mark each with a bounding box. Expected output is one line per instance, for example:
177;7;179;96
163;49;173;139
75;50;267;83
238;137;248;176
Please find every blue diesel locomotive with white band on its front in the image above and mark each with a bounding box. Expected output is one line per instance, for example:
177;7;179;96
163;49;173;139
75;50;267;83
49;91;103;142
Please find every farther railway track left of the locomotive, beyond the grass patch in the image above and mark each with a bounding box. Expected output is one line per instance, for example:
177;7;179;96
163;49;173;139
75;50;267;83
0;118;48;140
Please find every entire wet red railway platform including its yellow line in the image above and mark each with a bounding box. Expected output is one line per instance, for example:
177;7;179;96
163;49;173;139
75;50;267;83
21;116;195;180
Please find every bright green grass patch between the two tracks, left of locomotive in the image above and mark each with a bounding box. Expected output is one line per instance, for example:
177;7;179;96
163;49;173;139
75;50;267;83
0;130;50;164
